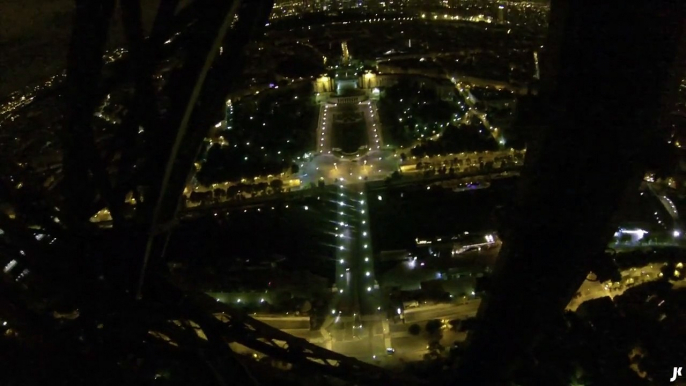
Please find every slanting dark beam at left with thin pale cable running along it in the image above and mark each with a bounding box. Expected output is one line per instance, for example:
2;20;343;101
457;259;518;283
137;1;245;297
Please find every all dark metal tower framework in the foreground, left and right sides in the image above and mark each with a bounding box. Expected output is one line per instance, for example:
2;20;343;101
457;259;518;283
12;0;686;386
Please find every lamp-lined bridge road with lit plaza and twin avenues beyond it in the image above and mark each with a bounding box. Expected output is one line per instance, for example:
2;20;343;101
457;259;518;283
316;100;390;334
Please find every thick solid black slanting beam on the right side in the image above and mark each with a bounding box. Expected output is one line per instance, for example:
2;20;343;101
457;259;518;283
451;0;686;386
